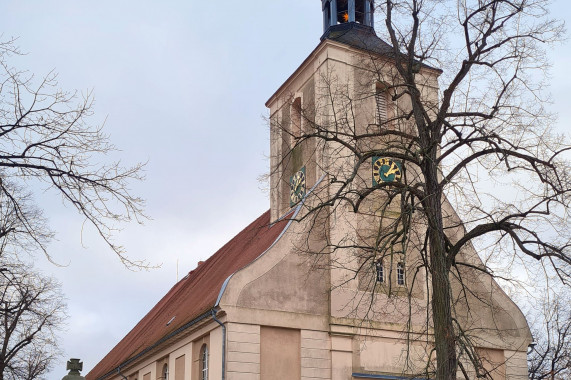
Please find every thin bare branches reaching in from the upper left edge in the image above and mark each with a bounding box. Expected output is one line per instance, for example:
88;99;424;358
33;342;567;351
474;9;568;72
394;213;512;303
0;37;144;267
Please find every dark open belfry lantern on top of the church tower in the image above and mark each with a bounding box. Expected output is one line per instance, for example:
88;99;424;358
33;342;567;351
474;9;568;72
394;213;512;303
321;0;374;33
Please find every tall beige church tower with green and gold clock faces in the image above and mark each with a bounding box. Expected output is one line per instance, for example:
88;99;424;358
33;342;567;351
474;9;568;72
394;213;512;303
266;0;530;379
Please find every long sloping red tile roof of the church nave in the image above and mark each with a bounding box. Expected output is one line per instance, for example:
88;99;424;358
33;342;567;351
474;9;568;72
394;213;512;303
86;211;287;380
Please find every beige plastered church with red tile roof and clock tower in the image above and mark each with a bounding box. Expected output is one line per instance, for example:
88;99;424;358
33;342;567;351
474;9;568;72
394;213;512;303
86;0;532;380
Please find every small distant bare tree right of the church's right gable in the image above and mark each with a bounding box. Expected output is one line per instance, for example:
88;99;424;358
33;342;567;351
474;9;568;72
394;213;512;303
528;291;571;380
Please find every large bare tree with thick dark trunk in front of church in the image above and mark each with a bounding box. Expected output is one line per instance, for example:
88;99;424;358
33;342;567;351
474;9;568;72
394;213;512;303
271;0;571;379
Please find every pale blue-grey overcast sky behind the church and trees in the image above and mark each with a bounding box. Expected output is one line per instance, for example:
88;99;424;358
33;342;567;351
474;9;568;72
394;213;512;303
0;0;571;380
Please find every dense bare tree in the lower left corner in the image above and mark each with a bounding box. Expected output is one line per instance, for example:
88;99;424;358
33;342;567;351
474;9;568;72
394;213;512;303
0;257;66;380
